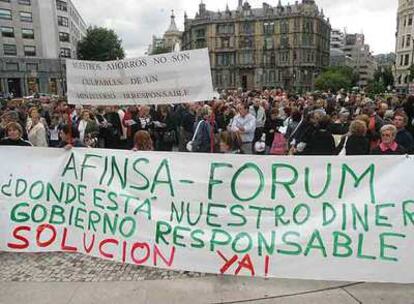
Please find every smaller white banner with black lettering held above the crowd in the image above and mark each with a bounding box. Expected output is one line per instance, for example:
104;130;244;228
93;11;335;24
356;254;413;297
66;49;214;105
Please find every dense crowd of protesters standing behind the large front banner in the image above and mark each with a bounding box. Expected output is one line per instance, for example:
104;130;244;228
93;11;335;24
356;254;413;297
0;90;414;155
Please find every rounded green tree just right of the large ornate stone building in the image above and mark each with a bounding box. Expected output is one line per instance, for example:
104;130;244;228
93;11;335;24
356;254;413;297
315;67;358;92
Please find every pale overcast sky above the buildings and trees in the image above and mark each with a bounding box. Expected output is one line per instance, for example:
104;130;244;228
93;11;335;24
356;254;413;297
72;0;398;57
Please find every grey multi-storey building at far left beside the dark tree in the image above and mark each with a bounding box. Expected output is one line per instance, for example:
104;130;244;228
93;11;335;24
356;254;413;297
0;0;86;97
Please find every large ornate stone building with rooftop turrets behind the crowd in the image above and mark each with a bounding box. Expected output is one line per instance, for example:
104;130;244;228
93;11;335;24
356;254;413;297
183;0;331;91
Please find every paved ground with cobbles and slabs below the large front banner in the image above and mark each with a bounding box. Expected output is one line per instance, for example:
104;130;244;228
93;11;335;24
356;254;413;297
0;253;414;304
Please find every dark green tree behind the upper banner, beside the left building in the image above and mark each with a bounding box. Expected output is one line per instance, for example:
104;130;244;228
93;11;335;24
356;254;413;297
78;26;125;61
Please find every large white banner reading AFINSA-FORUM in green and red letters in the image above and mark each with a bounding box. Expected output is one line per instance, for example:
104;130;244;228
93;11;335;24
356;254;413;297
0;147;414;283
